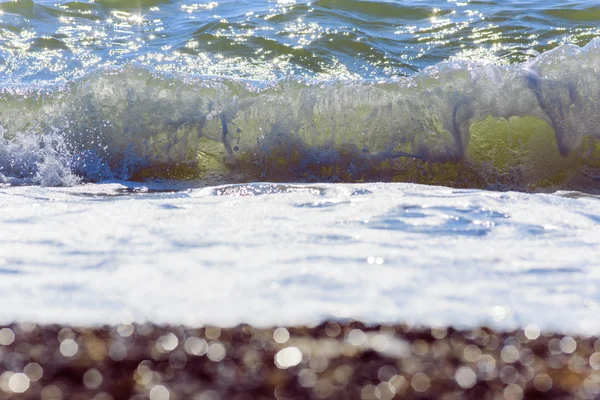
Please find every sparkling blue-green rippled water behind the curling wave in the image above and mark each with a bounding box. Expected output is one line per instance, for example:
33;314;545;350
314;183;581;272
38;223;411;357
0;0;600;82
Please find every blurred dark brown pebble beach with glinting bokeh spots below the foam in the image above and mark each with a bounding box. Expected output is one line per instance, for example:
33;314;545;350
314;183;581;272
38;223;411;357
0;321;600;400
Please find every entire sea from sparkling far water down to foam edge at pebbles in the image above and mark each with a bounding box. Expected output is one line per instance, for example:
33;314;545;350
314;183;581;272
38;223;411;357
0;0;600;334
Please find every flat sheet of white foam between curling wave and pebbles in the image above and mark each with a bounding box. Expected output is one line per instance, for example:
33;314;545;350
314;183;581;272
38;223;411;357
0;182;600;334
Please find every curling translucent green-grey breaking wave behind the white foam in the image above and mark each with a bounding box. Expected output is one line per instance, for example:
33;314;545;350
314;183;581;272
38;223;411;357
0;39;600;190
